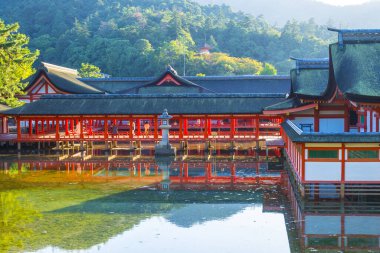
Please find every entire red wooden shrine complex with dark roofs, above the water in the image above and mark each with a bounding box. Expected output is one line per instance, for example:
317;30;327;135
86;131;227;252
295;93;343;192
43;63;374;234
0;29;380;196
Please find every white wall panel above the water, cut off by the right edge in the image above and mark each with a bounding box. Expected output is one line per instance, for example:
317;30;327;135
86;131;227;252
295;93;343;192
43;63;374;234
346;161;380;181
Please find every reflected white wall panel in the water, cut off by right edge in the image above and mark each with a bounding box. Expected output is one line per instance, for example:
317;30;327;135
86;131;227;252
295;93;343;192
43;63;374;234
345;216;380;235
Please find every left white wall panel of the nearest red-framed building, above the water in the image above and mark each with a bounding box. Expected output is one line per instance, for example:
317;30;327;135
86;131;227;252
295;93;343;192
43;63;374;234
305;162;341;181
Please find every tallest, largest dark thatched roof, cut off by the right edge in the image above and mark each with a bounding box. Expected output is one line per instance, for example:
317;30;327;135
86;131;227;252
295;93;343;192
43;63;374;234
329;29;380;103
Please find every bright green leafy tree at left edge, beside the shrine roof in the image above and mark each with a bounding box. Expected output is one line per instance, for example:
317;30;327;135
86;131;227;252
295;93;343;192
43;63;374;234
0;20;39;106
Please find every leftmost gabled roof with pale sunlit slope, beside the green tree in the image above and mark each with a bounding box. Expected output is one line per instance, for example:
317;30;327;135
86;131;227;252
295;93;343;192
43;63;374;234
24;62;105;94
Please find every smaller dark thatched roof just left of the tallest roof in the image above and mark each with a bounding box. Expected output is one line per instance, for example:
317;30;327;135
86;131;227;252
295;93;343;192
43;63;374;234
290;58;329;100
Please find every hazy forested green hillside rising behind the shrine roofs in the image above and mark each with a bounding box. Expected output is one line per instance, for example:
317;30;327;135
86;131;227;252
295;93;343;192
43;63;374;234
0;0;336;76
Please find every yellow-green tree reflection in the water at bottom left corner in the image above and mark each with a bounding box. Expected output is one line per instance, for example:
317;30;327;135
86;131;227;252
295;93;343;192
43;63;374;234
0;192;39;252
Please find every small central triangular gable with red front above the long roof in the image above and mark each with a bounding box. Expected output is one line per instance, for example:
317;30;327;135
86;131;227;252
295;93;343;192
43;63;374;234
120;66;214;94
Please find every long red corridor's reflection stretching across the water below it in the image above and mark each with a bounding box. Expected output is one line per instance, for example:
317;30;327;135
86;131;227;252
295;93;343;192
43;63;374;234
2;159;283;190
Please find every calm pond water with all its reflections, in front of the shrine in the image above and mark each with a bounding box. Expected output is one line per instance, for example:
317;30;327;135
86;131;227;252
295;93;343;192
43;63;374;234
0;151;380;253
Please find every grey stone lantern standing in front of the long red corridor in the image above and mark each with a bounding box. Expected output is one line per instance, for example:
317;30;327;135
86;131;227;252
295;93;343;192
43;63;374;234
155;109;176;156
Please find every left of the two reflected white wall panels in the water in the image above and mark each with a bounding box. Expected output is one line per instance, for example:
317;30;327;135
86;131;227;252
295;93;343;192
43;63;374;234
305;216;341;235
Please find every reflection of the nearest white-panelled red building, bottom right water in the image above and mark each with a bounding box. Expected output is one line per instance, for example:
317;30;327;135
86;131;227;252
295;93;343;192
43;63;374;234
285;175;380;252
